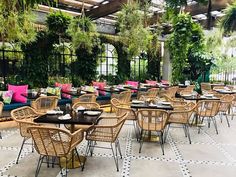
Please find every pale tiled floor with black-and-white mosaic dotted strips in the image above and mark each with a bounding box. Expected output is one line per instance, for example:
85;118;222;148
0;115;236;177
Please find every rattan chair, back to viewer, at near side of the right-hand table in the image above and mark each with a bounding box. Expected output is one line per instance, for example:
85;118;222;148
195;100;220;134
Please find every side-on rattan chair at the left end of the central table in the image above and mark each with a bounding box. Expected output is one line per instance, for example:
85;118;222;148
111;98;139;139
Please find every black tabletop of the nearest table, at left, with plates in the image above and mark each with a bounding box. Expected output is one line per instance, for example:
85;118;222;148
34;110;102;125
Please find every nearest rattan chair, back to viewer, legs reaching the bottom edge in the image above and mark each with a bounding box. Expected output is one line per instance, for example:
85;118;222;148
27;126;84;177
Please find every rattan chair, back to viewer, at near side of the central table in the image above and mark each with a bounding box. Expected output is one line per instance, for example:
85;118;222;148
137;109;168;155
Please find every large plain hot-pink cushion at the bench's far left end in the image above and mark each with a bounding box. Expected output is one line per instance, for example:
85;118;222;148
8;84;28;103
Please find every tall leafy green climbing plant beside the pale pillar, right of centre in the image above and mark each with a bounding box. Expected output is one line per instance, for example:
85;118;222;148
168;14;212;84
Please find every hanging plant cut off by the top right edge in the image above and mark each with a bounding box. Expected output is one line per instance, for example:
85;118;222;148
219;2;236;33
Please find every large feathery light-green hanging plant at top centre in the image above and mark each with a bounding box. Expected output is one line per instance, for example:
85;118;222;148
117;3;150;59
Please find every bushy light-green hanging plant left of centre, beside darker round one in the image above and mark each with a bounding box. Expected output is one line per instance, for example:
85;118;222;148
68;16;98;53
